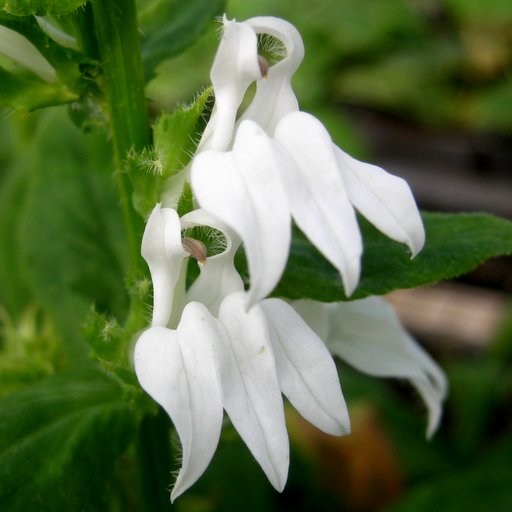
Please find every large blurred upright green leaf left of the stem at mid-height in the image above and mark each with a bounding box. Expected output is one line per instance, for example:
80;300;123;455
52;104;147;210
18;109;127;354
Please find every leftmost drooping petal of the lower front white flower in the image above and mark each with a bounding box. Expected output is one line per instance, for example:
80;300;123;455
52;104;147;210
134;303;223;500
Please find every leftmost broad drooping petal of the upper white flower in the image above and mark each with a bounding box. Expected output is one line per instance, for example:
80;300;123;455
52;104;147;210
191;121;291;304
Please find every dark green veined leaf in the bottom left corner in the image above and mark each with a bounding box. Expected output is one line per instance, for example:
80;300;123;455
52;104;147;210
0;369;135;512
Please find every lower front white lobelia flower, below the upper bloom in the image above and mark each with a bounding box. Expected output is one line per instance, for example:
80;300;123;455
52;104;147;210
134;205;350;500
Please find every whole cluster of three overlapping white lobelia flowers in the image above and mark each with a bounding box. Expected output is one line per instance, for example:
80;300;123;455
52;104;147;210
134;17;446;500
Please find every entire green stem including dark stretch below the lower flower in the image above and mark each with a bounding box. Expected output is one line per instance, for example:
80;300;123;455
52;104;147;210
91;0;171;512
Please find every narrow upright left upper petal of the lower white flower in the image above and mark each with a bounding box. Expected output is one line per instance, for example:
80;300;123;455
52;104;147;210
141;204;188;326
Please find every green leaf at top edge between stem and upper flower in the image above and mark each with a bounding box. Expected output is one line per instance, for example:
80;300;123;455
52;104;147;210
138;0;225;78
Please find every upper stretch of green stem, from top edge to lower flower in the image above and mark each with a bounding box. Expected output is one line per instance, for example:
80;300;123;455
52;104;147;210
92;0;150;275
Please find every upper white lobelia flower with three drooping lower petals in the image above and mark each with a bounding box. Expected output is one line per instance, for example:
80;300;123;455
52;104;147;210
191;17;424;304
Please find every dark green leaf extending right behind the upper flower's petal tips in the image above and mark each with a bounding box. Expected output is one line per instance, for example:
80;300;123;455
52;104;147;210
252;213;512;302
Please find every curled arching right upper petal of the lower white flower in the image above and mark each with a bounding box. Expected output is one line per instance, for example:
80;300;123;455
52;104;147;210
181;209;244;316
